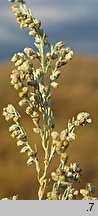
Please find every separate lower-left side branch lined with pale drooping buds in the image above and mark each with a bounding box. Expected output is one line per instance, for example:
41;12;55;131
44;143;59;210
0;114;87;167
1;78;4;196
3;105;37;165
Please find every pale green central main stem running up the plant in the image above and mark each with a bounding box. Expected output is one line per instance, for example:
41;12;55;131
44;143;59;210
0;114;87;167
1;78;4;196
38;35;50;200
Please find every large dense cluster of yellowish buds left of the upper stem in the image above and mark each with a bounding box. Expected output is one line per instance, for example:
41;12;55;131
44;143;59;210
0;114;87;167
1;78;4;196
11;48;42;89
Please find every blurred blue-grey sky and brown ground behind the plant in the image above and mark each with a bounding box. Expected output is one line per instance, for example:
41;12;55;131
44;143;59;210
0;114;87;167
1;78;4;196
0;0;98;199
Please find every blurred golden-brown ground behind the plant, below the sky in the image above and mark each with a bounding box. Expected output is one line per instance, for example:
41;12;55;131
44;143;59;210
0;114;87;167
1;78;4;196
0;56;98;199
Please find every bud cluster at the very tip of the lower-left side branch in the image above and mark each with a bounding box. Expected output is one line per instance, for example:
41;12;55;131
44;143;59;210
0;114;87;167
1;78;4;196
3;104;20;122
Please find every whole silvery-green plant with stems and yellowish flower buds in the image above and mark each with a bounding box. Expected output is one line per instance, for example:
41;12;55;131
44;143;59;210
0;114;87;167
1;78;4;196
3;0;97;200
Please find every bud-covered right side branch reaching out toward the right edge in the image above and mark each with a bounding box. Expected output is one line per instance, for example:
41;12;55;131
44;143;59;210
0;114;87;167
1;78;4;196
51;112;91;164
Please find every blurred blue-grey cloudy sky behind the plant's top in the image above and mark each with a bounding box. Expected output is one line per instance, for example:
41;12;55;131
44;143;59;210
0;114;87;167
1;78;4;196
0;0;98;60
